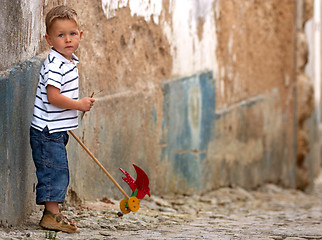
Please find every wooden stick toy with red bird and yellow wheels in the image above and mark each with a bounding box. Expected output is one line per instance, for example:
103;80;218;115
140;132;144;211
68;131;150;214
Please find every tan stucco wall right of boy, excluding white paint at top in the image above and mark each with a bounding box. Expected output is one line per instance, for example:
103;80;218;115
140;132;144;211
64;1;296;199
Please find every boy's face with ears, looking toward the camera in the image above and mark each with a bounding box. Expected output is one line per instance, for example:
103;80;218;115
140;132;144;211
45;19;83;60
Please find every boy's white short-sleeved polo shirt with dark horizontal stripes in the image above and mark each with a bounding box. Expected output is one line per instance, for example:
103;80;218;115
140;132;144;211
31;49;79;133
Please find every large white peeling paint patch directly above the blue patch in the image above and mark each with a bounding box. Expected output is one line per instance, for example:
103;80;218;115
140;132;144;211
162;0;218;76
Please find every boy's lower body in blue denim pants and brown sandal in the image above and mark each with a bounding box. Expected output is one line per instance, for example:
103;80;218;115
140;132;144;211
30;128;79;233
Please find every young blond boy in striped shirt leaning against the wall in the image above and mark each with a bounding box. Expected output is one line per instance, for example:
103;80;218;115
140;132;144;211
30;6;95;233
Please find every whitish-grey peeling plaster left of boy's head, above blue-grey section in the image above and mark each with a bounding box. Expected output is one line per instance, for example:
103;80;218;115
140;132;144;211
0;0;44;70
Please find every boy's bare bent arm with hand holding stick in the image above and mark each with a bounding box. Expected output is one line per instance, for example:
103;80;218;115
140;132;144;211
47;85;95;111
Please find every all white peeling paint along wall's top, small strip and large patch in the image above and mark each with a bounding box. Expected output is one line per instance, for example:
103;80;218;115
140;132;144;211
102;0;218;76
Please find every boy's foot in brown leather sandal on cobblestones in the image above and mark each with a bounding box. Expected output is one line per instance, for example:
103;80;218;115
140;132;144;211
39;210;79;233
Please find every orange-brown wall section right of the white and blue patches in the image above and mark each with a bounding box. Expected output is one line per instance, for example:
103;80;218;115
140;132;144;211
207;1;296;190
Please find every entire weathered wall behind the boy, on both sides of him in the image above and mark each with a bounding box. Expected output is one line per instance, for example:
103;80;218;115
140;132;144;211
0;0;315;225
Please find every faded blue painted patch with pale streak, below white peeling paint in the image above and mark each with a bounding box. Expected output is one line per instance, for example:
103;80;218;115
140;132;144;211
161;72;216;191
